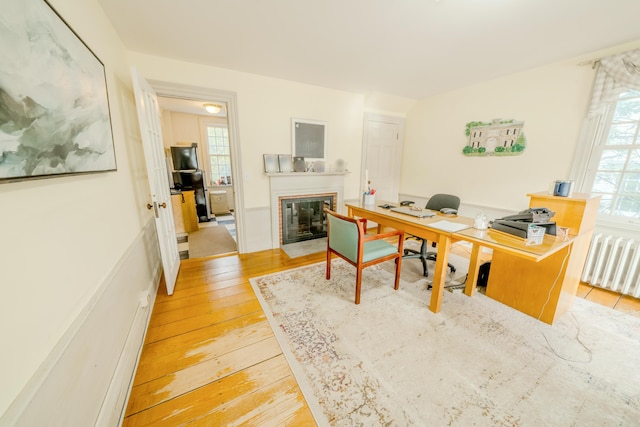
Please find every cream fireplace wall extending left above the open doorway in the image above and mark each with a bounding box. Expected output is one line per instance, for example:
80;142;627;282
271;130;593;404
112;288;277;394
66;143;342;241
131;53;413;209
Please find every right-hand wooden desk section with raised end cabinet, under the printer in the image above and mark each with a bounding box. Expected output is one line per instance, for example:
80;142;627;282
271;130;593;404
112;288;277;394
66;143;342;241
455;193;600;324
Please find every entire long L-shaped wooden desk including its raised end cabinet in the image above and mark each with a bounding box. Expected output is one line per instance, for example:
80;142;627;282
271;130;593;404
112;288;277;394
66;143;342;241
346;193;600;324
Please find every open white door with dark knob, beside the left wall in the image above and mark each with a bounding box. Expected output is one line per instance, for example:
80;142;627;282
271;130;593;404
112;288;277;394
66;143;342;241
131;68;180;295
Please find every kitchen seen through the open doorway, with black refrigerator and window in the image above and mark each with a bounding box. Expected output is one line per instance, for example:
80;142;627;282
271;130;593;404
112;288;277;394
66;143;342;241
158;95;238;259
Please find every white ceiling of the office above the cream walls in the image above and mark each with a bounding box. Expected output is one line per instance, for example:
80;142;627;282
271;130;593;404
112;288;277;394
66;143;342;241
99;0;640;98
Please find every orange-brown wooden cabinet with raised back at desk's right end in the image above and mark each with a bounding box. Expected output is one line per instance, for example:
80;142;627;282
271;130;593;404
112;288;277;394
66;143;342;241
486;193;600;324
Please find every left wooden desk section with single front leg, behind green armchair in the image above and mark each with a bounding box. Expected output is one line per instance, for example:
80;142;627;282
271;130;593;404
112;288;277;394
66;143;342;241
345;201;473;313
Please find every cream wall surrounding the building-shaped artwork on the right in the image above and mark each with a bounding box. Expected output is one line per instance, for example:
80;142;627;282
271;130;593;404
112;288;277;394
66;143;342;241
400;41;630;214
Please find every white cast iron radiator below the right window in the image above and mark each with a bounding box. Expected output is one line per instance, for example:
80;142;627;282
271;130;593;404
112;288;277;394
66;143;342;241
581;234;640;298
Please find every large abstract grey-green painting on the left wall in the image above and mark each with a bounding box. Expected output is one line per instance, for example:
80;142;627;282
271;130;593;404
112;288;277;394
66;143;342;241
0;0;116;182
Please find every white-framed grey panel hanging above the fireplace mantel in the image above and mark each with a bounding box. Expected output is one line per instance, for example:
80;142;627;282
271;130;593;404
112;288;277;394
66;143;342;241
291;118;327;161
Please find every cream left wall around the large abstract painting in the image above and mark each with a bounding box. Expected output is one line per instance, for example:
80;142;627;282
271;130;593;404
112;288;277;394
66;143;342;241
0;0;159;425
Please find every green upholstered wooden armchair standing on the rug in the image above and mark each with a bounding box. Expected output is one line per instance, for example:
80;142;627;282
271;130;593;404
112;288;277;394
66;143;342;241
325;209;404;304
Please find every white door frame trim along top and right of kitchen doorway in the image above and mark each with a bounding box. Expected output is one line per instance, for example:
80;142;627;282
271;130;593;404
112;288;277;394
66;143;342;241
148;80;246;254
